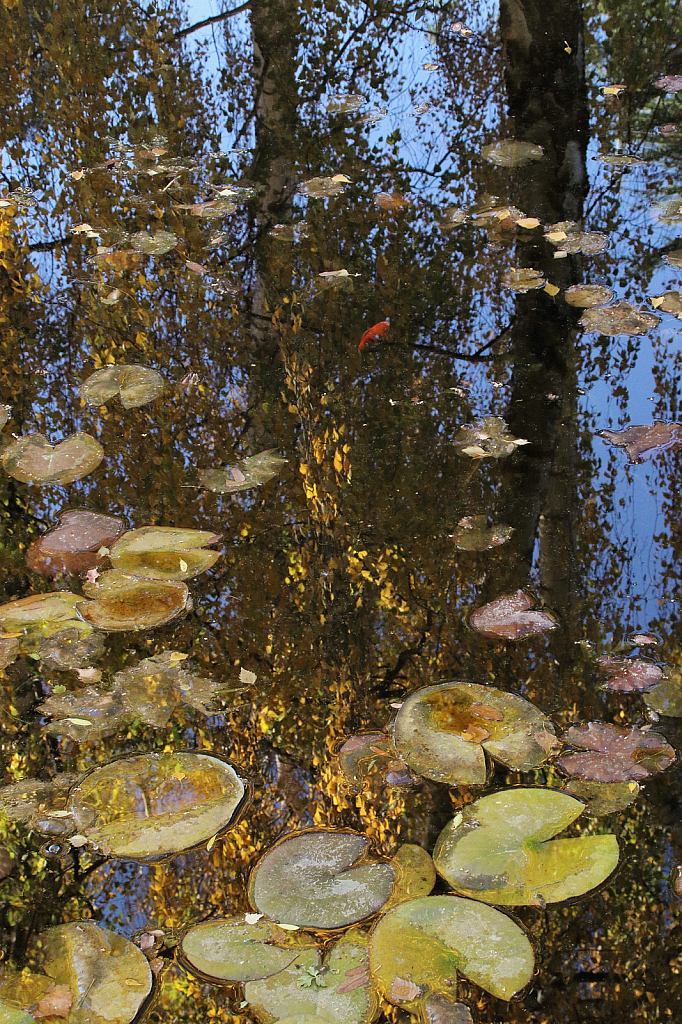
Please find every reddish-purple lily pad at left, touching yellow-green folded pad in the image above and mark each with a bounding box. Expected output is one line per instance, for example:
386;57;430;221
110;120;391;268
26;509;124;575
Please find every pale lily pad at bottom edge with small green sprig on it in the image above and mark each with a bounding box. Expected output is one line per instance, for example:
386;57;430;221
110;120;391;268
244;929;377;1024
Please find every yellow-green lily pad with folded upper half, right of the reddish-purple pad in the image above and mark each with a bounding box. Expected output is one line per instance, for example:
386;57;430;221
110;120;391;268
111;526;220;580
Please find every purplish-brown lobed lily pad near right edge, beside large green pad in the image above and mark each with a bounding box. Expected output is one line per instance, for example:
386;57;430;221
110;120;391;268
558;722;675;782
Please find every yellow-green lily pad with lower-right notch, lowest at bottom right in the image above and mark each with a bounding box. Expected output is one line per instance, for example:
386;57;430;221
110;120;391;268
370;896;535;1013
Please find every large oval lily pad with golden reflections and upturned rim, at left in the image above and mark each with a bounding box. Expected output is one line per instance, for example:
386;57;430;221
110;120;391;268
69;753;246;860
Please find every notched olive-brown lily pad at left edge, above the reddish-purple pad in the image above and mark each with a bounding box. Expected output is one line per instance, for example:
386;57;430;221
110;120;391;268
1;431;104;483
